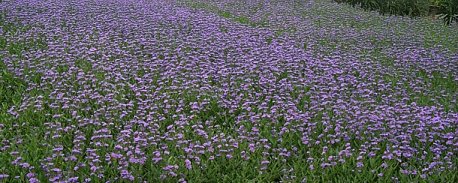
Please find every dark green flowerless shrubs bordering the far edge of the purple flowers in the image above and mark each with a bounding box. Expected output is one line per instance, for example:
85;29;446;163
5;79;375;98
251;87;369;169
335;0;458;24
